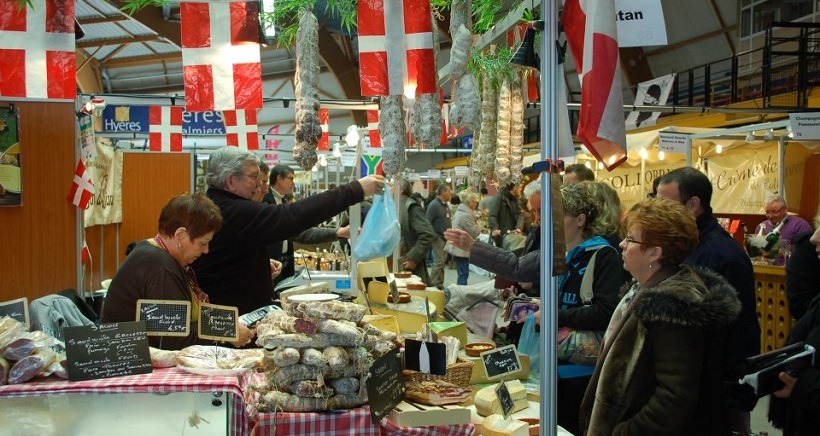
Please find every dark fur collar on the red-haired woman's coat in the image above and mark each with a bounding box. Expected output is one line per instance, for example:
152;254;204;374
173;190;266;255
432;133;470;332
635;265;740;329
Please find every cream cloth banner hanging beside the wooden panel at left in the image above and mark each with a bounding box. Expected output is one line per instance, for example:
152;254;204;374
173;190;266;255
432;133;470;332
84;138;122;227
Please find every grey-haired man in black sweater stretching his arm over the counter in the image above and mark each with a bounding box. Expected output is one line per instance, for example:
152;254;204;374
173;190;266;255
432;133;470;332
193;147;384;313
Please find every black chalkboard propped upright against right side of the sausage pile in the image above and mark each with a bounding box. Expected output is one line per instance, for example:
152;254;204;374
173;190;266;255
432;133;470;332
366;347;404;424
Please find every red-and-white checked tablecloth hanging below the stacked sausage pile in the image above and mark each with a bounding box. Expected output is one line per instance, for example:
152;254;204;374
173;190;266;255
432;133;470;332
243;374;475;436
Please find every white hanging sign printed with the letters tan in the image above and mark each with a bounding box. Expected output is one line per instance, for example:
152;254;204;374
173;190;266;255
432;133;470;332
615;0;667;47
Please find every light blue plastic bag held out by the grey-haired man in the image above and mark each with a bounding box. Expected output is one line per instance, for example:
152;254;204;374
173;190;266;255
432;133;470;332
353;193;401;260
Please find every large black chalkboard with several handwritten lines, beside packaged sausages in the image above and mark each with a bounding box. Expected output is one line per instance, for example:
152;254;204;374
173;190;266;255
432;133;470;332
63;321;153;381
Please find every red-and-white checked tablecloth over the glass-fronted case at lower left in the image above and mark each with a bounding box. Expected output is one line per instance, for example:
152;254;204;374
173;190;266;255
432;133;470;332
0;368;248;435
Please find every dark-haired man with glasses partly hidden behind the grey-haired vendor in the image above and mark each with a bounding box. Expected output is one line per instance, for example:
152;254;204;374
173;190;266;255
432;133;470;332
262;165;350;290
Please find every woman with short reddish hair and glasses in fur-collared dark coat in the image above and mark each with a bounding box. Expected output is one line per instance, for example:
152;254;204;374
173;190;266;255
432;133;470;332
580;199;740;435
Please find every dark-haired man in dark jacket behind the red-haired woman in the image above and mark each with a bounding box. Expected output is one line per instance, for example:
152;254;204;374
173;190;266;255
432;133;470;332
657;167;760;434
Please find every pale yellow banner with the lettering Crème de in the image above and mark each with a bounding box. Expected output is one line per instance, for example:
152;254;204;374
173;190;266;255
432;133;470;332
706;144;780;215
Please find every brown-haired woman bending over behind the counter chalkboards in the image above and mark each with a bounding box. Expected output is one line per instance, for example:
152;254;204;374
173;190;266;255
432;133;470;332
102;194;253;350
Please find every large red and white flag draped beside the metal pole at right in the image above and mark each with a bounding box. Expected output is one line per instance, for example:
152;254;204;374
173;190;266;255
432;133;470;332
561;0;626;171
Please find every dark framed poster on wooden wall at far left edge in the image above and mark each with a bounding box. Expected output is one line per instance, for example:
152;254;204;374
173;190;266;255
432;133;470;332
0;106;23;206
